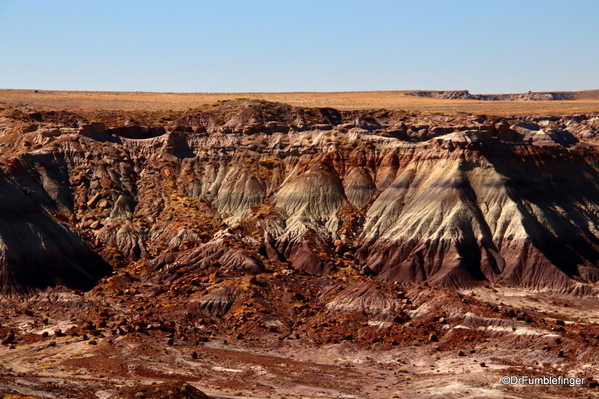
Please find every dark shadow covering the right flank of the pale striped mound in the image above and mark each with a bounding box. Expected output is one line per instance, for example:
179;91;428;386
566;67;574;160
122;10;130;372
482;145;599;277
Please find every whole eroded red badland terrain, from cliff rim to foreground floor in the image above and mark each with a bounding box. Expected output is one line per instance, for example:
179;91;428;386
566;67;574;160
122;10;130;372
0;99;599;397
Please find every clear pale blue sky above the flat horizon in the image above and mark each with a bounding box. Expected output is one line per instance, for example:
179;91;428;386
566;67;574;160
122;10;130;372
0;0;599;93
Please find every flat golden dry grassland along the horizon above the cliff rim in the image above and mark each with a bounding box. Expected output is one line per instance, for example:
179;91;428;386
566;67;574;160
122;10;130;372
0;89;599;116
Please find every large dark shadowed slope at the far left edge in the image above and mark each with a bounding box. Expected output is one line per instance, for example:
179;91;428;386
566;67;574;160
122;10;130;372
0;175;111;295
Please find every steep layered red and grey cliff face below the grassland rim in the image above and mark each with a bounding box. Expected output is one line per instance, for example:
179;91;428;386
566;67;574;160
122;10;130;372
0;103;599;296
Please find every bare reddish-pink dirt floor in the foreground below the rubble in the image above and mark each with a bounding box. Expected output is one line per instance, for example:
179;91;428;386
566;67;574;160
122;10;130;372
0;287;599;399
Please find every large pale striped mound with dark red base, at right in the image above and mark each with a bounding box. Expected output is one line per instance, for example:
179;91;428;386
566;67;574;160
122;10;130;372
359;146;599;292
